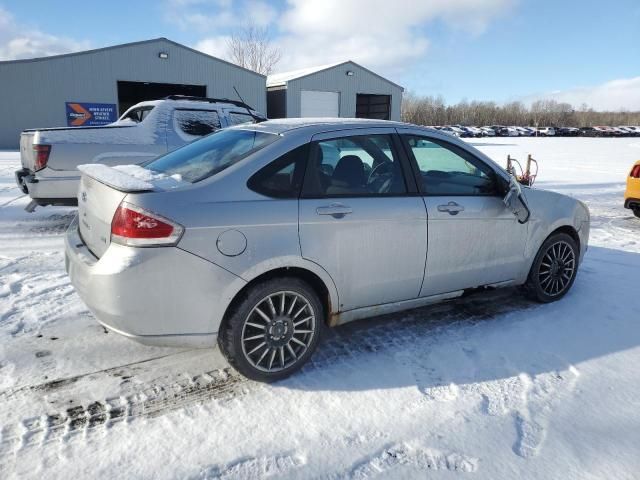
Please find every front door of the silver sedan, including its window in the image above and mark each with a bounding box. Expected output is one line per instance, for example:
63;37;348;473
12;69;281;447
400;131;528;296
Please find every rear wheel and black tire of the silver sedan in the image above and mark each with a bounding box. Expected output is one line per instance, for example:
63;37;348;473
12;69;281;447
218;277;325;382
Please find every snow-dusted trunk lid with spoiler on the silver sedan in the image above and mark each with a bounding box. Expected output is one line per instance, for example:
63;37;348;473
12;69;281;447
78;164;189;258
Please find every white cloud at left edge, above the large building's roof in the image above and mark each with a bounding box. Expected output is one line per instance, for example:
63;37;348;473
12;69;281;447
0;7;89;60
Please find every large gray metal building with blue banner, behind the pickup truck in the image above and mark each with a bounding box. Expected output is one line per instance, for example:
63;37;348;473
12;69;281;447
0;38;267;149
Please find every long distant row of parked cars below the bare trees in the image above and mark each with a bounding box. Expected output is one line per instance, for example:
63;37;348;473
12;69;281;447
432;125;640;138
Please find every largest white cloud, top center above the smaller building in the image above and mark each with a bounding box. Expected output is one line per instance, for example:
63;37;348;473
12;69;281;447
186;0;518;75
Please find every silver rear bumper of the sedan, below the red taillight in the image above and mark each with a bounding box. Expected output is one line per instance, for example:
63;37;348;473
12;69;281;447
65;219;244;348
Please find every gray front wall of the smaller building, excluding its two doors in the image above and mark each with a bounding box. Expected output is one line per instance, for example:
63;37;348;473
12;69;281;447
287;63;402;120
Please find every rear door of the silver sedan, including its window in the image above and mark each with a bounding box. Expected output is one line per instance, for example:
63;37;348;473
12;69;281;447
299;128;427;311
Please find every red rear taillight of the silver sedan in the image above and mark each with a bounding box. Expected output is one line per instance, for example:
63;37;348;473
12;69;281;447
111;202;184;247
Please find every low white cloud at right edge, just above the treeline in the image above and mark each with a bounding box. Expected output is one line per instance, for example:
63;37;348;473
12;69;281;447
525;77;640;111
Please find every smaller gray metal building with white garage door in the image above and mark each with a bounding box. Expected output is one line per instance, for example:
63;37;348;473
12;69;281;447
267;60;404;120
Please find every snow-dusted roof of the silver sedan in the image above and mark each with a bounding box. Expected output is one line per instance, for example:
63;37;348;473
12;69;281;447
242;118;412;134
